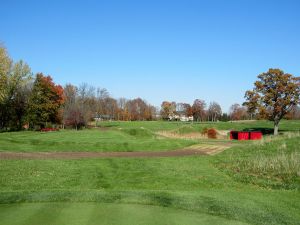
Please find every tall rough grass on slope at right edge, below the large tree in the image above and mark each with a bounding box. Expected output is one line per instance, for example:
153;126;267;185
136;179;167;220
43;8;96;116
218;132;300;190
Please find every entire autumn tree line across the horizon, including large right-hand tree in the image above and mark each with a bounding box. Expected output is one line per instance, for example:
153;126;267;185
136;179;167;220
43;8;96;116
0;46;300;130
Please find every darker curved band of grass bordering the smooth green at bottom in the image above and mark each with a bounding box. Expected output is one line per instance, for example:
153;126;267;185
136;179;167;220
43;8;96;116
0;190;299;225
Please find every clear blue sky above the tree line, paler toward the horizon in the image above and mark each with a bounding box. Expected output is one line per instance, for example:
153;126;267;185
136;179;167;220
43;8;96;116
0;0;300;112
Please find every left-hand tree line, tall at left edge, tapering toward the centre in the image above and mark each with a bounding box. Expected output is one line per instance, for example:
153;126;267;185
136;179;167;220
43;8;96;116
0;46;157;130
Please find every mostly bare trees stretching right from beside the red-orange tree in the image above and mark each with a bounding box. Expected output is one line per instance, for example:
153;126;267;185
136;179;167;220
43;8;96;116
62;83;157;129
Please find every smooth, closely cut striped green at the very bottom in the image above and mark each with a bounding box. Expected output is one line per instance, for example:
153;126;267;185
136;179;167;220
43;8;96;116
0;203;246;225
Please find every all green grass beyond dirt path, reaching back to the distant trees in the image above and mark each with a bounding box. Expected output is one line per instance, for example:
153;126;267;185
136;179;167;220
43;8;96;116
0;121;300;152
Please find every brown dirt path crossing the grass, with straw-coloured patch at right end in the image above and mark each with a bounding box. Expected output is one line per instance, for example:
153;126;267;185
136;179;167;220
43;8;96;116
0;145;229;160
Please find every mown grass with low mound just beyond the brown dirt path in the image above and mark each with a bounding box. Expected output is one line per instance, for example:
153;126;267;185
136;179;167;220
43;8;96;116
0;128;198;152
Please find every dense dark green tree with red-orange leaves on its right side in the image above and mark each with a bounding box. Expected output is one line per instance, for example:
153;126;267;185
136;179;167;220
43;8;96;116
28;73;64;127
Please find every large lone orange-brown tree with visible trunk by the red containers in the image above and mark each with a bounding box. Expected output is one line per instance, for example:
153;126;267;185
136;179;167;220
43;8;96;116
245;69;300;135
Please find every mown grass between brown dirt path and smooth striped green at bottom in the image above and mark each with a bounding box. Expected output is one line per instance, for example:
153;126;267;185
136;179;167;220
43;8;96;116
0;152;300;225
